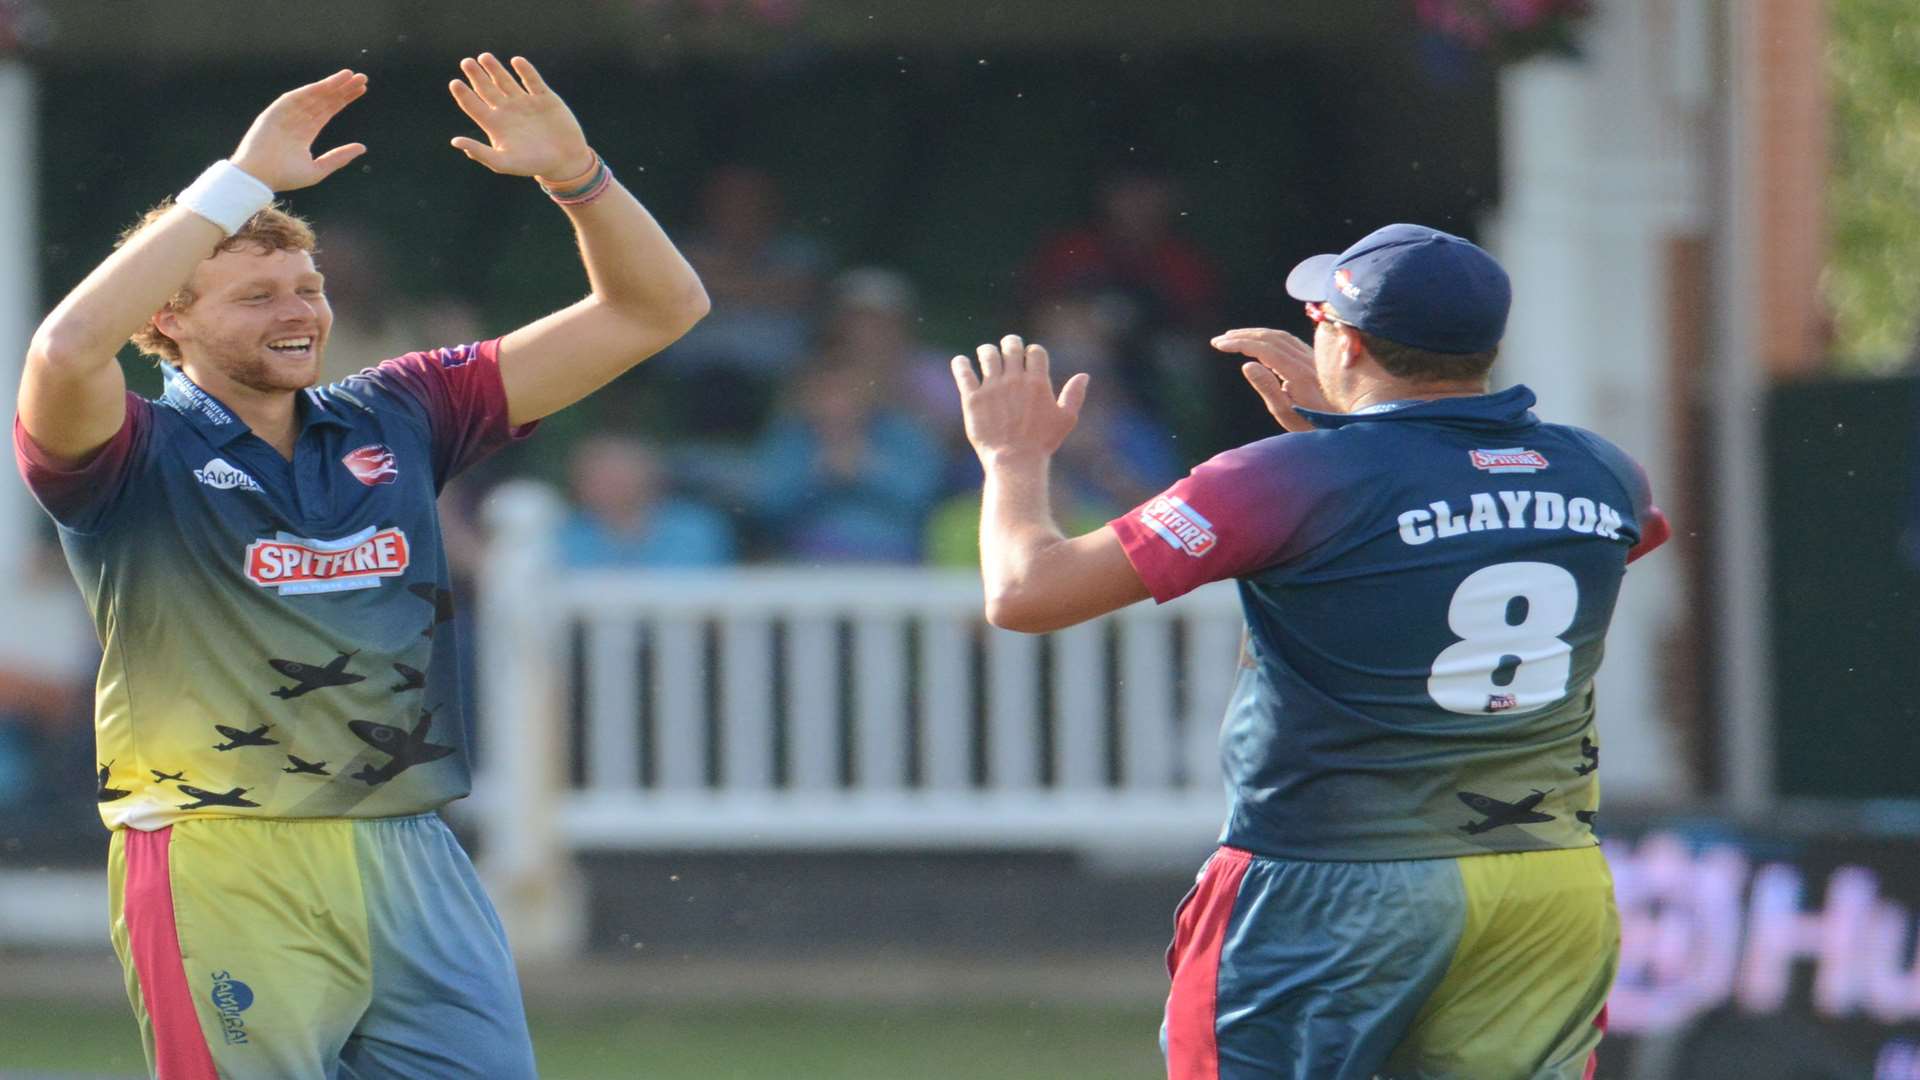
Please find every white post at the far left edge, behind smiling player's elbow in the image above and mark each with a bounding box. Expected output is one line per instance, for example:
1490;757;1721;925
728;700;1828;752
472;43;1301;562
0;60;40;580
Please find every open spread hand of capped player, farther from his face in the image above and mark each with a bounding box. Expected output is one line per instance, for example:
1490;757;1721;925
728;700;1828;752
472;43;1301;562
952;334;1087;463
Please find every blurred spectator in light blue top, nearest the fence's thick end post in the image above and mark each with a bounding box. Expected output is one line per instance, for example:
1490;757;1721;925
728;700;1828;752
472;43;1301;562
559;434;735;569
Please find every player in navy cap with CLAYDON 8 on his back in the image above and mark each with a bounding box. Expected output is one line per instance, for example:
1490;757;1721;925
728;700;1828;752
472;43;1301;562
952;225;1668;1080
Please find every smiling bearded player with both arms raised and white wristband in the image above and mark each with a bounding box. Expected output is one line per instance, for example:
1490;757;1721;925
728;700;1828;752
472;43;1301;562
13;54;707;1080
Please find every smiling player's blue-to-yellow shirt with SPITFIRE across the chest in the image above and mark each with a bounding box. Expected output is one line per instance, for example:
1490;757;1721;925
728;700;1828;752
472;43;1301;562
13;340;528;830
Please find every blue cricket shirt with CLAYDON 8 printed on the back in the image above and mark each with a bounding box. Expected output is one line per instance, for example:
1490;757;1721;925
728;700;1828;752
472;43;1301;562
1112;386;1668;861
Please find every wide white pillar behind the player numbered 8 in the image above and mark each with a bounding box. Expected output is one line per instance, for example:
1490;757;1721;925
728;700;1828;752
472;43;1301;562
1488;0;1709;801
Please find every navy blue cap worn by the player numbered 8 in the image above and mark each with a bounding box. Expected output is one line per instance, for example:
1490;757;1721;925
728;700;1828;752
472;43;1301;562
1286;225;1513;354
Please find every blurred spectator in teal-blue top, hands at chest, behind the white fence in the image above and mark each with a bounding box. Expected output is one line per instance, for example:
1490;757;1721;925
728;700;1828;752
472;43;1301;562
751;348;941;563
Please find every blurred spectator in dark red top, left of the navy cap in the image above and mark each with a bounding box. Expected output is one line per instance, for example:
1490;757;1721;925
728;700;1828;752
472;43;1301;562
1023;161;1225;434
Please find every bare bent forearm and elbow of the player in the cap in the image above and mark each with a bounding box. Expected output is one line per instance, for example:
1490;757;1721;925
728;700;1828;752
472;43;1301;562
979;452;1148;634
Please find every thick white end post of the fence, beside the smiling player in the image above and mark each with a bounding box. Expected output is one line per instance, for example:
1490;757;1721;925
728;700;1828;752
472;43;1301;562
470;480;586;961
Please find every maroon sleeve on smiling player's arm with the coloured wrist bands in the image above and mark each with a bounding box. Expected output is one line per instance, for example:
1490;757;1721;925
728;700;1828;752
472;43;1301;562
349;338;540;484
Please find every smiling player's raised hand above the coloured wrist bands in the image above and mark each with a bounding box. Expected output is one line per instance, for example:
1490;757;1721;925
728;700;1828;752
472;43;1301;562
447;52;593;183
